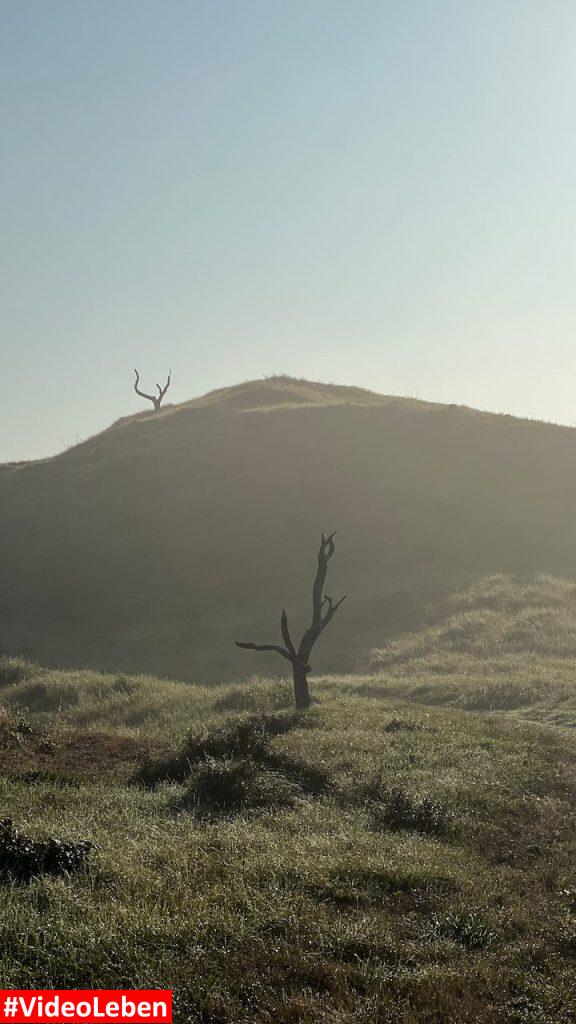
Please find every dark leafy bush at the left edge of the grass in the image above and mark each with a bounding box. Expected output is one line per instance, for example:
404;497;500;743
0;818;92;882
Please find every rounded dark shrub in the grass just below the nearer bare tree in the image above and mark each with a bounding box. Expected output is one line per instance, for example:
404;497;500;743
181;757;298;813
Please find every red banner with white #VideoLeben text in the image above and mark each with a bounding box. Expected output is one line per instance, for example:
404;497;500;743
0;989;172;1024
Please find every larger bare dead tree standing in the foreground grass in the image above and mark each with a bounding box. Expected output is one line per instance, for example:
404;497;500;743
236;534;346;709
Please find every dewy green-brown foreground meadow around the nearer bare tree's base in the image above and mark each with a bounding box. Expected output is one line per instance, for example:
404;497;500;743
0;643;576;1024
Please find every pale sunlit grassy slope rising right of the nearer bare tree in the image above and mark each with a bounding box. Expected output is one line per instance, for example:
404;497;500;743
358;574;576;726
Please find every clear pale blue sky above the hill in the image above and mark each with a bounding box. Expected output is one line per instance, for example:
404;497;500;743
0;0;576;462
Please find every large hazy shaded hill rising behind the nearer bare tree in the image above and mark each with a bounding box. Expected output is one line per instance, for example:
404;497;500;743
0;378;576;679
